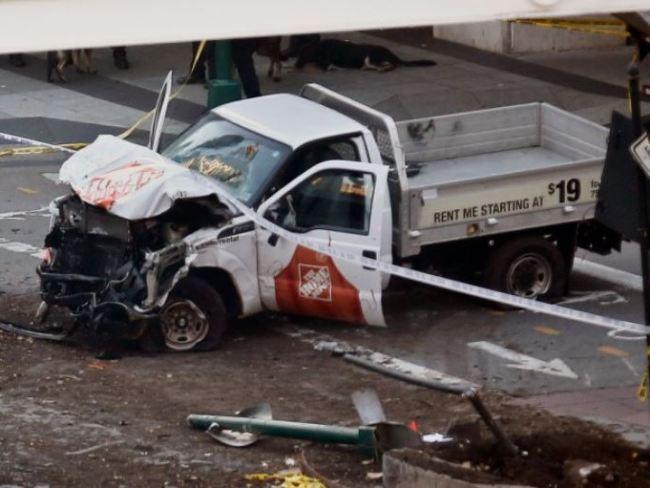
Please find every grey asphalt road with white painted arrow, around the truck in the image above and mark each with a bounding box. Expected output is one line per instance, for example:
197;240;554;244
0;150;646;404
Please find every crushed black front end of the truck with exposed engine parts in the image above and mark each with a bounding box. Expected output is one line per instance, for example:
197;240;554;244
38;194;229;338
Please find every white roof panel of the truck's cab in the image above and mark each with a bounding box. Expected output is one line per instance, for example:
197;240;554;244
213;93;367;149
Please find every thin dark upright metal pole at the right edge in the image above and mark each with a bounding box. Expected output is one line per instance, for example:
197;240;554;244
628;59;650;388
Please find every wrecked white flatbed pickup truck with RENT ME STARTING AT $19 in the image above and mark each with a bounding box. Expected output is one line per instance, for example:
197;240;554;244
39;85;620;350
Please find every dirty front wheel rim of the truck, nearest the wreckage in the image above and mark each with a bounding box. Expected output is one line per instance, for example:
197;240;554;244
160;300;210;351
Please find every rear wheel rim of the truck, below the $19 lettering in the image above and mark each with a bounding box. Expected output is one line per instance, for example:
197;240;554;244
506;253;552;298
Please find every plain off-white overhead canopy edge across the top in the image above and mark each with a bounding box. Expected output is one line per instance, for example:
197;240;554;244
0;0;648;53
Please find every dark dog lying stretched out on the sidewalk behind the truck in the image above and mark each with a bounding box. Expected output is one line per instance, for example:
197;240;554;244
296;39;436;72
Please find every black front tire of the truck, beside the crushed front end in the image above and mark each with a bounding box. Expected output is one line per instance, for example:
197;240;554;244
140;276;228;352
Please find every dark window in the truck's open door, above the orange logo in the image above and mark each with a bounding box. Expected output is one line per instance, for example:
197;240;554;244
265;170;375;234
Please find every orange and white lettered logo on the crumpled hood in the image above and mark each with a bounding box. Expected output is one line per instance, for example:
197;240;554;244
80;162;164;210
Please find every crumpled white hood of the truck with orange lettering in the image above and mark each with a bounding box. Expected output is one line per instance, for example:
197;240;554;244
59;135;237;220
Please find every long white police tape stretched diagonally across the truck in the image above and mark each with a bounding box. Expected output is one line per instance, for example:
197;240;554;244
0;132;650;340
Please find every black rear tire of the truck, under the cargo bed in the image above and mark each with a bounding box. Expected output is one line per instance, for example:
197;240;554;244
485;236;568;301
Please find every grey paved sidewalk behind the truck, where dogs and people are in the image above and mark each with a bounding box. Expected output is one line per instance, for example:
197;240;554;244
0;29;650;139
